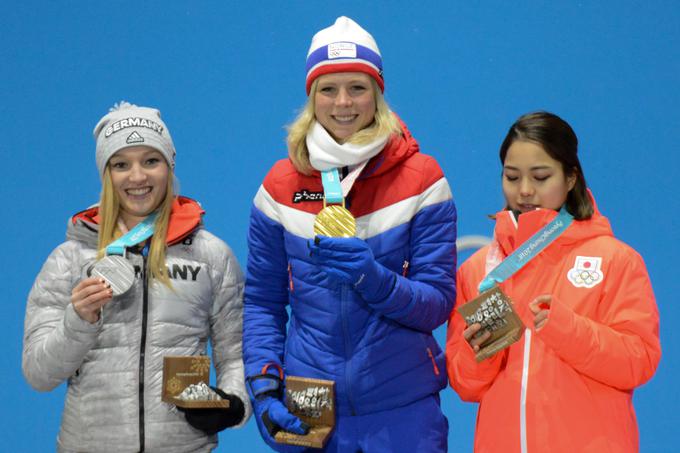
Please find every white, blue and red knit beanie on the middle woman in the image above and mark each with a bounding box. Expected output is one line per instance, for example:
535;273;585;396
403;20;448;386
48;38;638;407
306;16;385;94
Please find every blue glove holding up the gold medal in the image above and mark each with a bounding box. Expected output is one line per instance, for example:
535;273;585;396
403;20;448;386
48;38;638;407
309;236;397;302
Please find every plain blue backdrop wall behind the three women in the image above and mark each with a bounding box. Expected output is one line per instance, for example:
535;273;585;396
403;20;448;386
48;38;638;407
0;0;680;452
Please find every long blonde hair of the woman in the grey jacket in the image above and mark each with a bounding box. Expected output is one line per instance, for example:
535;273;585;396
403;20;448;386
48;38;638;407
97;165;175;288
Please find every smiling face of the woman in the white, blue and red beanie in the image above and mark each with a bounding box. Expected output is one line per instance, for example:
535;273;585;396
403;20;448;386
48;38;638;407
314;72;375;143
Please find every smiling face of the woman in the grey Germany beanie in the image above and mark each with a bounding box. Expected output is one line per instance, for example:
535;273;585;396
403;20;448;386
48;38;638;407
108;146;170;228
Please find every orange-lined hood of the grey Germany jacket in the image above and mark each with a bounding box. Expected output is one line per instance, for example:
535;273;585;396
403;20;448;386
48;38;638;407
66;196;205;247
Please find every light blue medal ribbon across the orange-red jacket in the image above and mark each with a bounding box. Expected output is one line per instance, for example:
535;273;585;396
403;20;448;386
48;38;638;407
479;206;574;293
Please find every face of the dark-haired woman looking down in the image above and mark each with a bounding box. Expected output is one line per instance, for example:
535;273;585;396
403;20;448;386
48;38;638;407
503;140;576;212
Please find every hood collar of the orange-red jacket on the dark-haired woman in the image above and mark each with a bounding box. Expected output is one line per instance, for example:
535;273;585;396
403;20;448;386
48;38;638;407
494;193;614;256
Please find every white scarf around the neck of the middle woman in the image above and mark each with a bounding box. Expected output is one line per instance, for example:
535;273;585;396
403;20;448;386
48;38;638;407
306;121;390;171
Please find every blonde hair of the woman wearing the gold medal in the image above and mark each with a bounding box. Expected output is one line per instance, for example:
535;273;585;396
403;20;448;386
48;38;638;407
286;78;402;175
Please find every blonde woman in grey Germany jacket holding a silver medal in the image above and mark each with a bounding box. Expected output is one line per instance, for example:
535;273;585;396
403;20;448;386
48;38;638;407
23;103;251;452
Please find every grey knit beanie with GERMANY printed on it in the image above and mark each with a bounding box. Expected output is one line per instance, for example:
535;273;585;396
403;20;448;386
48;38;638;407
93;101;175;177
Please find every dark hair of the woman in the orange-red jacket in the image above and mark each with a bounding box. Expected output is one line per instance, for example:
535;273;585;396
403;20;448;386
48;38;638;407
500;111;595;220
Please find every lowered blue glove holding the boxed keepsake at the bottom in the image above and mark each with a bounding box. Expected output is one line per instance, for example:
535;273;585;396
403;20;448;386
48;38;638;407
247;365;309;453
